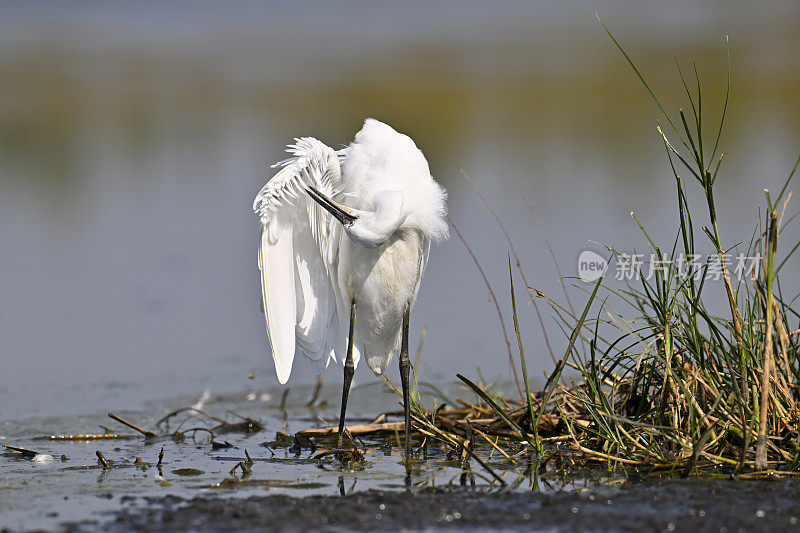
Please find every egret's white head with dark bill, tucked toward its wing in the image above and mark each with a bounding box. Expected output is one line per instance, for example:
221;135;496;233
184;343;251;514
308;188;406;248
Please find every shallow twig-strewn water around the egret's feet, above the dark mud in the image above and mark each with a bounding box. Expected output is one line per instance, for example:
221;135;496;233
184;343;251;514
0;385;603;530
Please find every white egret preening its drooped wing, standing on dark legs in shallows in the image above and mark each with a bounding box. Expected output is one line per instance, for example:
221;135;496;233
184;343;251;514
253;119;448;458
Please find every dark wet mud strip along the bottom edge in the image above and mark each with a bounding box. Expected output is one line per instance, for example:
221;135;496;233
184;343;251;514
63;480;800;532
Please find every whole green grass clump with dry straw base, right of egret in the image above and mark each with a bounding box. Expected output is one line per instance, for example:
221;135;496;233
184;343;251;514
404;21;800;476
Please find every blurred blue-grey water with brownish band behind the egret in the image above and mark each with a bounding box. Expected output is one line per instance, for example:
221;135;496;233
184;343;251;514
0;0;800;419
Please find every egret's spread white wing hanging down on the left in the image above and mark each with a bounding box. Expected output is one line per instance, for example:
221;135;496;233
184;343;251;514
253;137;341;384
